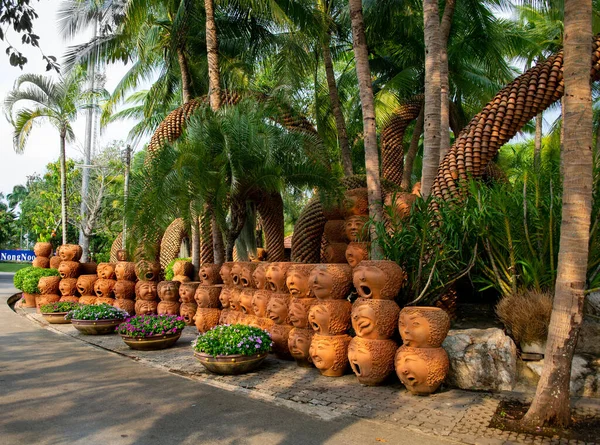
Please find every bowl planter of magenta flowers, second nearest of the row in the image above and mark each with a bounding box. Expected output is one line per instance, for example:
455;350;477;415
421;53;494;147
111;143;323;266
116;314;185;351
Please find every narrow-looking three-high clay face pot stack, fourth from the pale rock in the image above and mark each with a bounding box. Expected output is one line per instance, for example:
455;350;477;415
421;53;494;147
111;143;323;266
286;264;317;368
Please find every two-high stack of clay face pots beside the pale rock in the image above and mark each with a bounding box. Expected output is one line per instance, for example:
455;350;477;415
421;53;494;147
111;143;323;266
395;307;450;395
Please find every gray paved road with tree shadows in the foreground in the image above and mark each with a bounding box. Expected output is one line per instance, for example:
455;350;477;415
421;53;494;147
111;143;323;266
0;273;448;445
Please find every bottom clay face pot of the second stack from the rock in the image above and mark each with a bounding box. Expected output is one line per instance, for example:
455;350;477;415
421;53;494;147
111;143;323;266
348;337;398;385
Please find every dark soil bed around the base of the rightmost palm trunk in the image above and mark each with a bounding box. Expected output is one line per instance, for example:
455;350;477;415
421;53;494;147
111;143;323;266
490;400;600;443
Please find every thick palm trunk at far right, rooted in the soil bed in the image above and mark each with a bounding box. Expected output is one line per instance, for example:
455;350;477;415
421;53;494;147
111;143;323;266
523;0;593;427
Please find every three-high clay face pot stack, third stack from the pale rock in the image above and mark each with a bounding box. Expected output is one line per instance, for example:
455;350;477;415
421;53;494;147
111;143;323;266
308;264;352;377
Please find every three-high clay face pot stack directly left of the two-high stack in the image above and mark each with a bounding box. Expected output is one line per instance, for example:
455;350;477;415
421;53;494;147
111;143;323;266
348;260;404;385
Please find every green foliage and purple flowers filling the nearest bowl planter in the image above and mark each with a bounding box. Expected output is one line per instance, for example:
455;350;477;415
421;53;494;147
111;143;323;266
192;324;273;357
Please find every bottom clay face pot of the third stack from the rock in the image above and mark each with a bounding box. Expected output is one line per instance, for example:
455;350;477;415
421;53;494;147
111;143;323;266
309;334;351;377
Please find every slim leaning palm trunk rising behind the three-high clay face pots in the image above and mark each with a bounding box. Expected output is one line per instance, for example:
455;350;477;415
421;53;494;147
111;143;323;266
349;0;383;260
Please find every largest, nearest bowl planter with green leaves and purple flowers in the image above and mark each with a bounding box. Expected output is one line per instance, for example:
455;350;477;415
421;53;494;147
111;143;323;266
192;324;273;375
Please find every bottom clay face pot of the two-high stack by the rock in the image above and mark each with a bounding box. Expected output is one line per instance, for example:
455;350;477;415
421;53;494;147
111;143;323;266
395;346;450;395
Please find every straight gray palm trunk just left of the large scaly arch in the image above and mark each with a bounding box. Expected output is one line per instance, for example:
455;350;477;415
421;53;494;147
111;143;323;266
421;0;441;198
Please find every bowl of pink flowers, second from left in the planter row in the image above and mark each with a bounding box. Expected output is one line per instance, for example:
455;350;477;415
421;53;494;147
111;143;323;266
66;303;129;335
